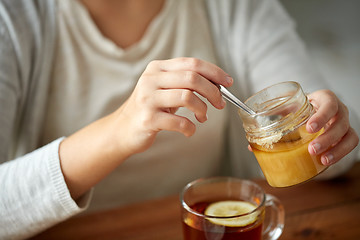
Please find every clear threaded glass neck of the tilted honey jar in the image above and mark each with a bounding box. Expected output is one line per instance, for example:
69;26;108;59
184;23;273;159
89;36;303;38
239;82;313;140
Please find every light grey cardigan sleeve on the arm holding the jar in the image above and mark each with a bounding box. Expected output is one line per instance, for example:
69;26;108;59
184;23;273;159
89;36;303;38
240;0;357;176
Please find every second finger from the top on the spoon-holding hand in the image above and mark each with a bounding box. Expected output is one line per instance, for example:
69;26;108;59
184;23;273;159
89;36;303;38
149;71;226;109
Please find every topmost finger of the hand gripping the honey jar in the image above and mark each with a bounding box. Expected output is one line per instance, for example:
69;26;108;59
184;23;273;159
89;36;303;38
306;90;338;133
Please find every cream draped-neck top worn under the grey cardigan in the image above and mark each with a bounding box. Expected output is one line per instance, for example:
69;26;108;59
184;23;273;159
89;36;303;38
42;0;226;212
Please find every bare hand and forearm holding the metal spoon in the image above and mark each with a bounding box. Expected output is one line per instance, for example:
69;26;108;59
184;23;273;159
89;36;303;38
59;58;233;199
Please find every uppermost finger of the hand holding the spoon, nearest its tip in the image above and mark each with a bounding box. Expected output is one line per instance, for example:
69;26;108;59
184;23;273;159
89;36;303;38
147;57;233;87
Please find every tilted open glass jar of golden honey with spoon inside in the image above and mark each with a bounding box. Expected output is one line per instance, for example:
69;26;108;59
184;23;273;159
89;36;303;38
239;82;326;187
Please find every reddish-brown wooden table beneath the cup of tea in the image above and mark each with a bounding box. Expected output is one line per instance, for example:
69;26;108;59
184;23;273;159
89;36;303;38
33;163;360;240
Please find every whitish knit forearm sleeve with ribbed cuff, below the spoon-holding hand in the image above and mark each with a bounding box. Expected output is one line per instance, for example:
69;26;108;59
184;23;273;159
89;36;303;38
0;138;91;239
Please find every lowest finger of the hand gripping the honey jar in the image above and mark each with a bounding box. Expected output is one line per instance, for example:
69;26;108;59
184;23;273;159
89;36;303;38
321;128;359;166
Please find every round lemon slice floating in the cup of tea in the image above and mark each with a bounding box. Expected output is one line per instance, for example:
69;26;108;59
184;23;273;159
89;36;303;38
205;201;258;227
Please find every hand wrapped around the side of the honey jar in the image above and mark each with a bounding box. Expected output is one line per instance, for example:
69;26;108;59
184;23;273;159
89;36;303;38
306;90;359;165
